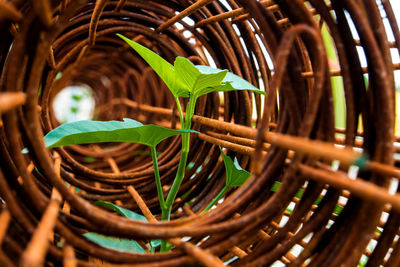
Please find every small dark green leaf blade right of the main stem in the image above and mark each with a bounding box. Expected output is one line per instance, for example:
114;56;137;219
221;151;251;188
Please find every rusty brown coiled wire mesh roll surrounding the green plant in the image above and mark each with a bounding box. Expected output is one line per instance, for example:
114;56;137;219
0;0;400;266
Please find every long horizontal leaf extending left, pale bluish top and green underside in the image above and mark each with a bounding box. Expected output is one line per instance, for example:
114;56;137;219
44;118;194;148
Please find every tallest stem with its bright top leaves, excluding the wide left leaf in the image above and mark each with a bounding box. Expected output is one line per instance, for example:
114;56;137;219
117;34;265;251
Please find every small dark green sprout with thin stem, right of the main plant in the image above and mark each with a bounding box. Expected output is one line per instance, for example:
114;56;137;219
203;150;251;212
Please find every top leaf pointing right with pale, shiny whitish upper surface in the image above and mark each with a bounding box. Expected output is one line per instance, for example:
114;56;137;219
196;65;265;95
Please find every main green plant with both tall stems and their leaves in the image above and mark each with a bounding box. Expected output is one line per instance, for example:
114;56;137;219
45;34;265;251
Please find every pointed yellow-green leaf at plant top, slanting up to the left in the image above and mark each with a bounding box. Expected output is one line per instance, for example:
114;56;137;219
117;34;187;97
